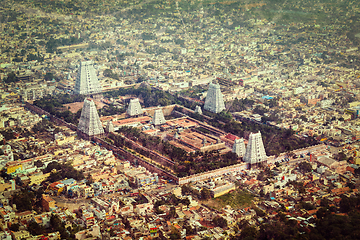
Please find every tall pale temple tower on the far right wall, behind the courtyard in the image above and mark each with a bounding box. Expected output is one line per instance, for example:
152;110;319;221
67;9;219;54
204;83;225;113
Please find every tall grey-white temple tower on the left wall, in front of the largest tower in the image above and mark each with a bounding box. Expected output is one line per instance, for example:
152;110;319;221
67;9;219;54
78;99;104;137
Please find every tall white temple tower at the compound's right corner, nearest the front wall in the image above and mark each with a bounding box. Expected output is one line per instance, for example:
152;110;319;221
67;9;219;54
244;131;267;164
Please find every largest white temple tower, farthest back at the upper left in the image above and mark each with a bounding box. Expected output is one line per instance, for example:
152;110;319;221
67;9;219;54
74;61;102;95
